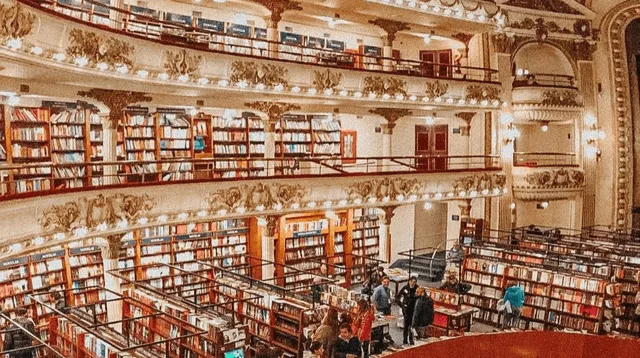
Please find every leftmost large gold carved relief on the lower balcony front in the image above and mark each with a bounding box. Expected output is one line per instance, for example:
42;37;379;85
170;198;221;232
39;194;155;232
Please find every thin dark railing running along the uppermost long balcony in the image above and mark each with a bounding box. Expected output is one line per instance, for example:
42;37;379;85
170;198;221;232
19;0;497;82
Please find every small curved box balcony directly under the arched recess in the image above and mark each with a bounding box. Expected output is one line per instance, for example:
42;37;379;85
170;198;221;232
512;74;583;123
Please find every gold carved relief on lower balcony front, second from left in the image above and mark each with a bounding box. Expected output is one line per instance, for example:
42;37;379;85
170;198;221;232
206;183;308;212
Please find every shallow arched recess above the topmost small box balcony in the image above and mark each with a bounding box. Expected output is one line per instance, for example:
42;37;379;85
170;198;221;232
511;41;576;77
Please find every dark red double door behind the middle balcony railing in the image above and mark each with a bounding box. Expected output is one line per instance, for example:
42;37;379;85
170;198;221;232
415;124;449;171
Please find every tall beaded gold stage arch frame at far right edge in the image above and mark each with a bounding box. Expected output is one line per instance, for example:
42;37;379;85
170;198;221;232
600;0;640;228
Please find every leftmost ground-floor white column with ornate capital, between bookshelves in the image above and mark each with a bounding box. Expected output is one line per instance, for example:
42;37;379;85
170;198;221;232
102;235;122;332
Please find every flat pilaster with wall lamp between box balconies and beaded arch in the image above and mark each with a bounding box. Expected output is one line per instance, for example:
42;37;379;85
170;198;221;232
576;61;598;225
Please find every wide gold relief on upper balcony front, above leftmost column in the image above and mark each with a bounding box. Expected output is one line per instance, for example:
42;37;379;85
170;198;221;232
66;29;134;67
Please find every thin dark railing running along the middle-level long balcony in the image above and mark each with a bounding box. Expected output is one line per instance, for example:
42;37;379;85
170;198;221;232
0;156;500;200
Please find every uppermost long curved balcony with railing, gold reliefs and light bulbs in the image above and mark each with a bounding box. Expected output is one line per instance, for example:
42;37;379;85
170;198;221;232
0;0;503;109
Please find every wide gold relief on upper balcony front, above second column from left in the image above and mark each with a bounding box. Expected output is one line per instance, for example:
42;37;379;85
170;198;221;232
230;61;289;87
